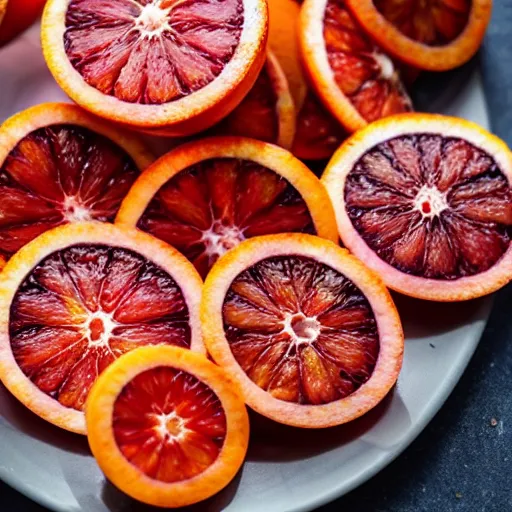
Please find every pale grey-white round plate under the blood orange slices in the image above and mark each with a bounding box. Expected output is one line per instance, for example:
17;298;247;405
0;22;491;512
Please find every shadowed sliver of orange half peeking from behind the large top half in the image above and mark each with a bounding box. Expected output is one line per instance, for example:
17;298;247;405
214;52;296;149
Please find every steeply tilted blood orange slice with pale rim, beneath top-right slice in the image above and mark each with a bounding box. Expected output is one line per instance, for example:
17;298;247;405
299;0;412;132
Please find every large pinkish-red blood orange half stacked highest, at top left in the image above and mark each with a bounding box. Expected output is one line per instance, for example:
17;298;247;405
42;0;268;135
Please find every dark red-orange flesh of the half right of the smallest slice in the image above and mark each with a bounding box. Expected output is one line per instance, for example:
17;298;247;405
223;256;379;405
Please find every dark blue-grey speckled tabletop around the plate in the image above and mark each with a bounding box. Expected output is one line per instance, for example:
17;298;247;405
0;0;512;512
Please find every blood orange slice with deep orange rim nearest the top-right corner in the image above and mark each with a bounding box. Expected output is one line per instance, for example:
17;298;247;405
345;0;492;71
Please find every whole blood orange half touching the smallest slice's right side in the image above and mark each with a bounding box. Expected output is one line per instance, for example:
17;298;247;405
201;233;404;428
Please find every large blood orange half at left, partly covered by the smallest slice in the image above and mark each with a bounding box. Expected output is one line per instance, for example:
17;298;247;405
0;222;204;434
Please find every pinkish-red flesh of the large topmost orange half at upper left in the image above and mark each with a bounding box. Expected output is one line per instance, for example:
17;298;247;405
64;0;244;105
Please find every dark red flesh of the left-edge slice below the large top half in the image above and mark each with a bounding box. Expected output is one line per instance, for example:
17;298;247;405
0;125;139;259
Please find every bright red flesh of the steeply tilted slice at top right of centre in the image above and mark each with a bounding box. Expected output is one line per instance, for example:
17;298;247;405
324;0;412;123
